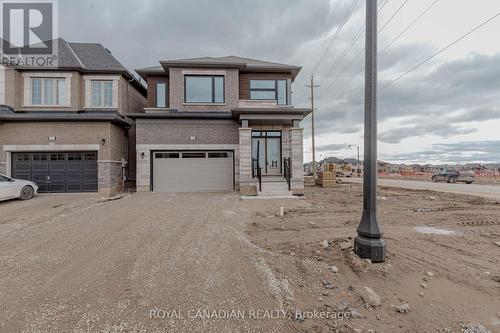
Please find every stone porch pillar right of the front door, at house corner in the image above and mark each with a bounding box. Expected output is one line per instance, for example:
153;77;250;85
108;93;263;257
290;127;304;195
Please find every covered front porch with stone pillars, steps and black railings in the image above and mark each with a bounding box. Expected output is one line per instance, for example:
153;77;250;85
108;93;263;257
233;108;309;197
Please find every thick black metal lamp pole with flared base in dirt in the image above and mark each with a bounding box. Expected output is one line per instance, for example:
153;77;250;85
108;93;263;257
354;0;386;262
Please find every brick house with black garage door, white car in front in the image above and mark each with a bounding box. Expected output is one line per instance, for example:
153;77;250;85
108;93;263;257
0;39;146;195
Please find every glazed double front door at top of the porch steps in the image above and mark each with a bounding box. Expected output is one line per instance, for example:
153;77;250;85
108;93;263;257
252;131;281;175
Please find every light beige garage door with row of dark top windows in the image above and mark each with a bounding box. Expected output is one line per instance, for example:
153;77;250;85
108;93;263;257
153;151;233;192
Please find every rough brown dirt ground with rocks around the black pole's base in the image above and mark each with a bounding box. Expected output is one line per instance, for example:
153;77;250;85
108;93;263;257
244;184;500;333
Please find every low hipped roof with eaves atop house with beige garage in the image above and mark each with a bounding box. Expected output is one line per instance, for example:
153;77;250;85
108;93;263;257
136;56;301;79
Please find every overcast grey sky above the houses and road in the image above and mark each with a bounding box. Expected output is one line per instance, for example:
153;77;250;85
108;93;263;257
59;0;500;163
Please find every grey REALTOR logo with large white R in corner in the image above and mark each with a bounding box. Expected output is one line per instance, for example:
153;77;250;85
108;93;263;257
0;0;58;66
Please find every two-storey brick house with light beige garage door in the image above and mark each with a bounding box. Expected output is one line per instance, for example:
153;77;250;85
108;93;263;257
131;56;310;195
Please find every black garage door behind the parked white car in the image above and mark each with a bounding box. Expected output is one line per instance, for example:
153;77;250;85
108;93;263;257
12;152;97;193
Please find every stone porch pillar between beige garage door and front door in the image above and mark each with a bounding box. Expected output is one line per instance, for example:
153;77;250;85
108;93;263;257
239;124;257;195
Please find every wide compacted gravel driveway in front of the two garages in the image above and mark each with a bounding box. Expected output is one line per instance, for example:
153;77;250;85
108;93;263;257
0;193;289;332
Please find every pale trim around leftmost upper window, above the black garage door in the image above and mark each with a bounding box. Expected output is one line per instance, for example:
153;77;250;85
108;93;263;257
23;72;73;108
